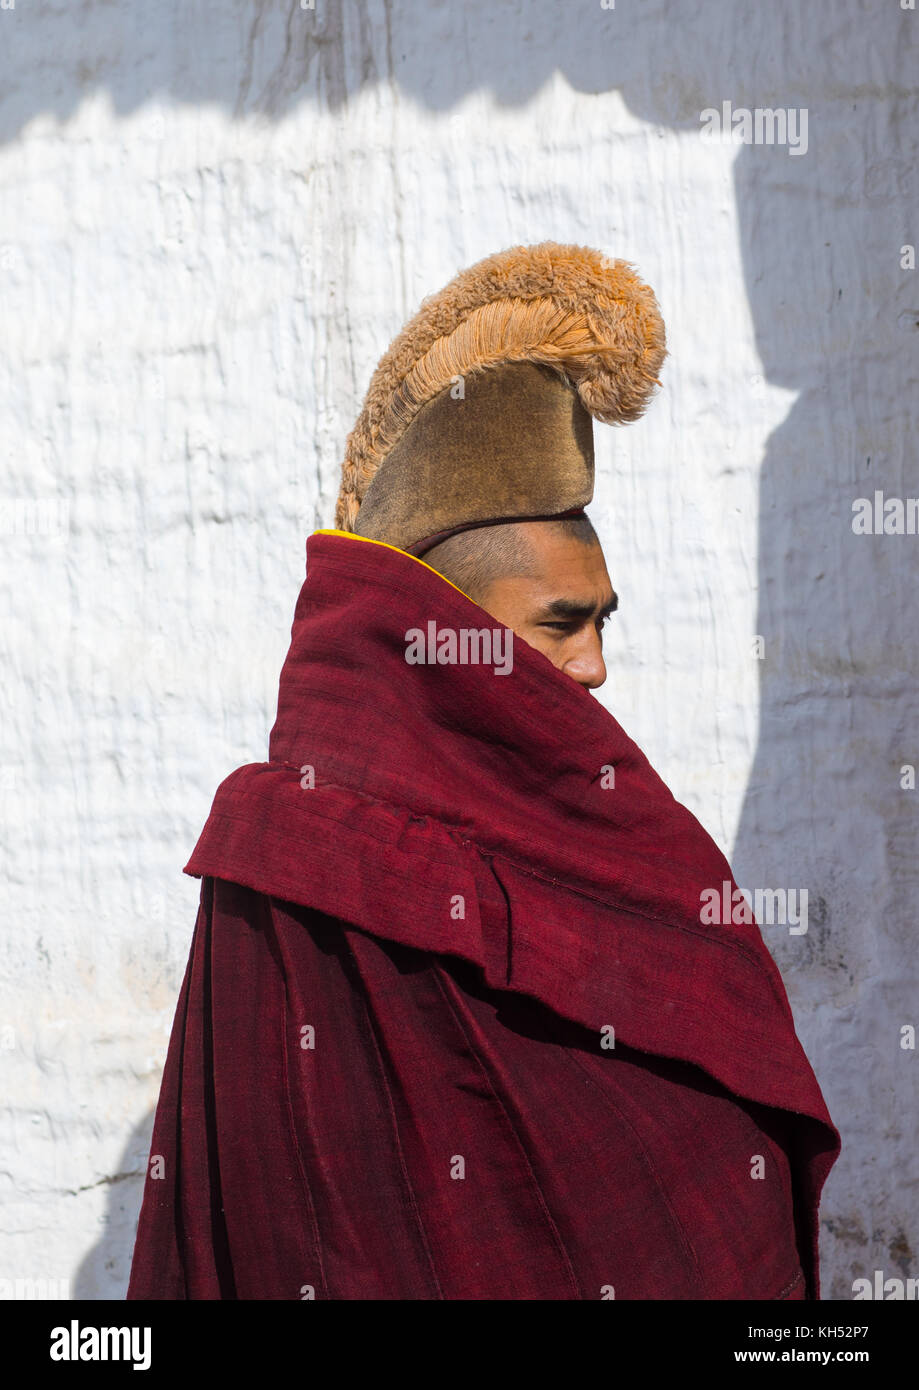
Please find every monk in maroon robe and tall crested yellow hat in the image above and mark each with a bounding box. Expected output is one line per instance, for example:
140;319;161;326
128;243;840;1300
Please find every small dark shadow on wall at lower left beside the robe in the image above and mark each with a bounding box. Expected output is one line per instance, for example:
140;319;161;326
71;1109;154;1300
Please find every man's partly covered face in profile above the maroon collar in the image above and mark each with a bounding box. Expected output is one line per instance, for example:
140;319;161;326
477;521;619;689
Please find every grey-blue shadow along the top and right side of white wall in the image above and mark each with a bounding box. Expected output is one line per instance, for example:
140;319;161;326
8;0;919;1297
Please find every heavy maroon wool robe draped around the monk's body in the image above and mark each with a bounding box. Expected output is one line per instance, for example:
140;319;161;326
128;532;840;1300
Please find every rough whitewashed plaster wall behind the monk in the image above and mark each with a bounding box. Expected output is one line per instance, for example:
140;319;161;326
0;0;919;1298
